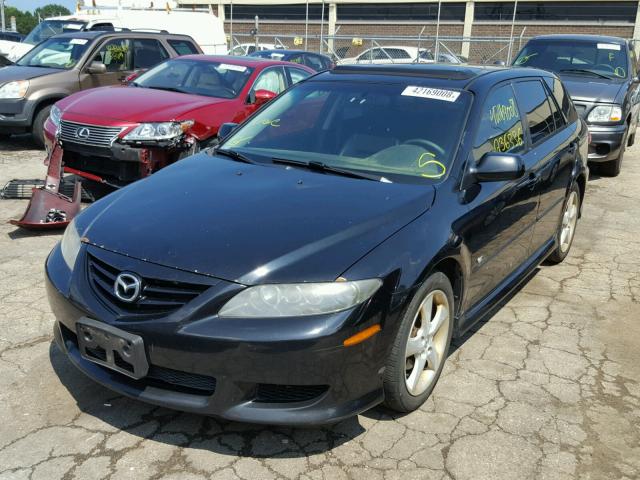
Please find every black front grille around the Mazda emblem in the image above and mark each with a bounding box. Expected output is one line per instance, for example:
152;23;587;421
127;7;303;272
87;253;210;315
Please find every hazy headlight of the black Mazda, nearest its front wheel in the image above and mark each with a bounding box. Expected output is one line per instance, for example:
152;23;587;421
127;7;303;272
219;278;382;318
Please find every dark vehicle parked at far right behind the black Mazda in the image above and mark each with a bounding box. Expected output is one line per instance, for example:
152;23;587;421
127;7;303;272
514;35;640;176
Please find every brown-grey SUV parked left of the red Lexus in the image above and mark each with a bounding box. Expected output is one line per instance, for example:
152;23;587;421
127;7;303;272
0;31;202;145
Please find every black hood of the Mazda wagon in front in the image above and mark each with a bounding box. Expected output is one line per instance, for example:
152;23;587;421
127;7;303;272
76;153;435;285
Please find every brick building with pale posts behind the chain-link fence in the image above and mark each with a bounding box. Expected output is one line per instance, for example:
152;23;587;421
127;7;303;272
178;0;640;61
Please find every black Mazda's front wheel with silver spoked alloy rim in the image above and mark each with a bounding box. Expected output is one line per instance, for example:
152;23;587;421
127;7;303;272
383;272;455;413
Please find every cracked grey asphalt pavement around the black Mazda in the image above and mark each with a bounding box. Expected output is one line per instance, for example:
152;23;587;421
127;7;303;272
0;138;640;480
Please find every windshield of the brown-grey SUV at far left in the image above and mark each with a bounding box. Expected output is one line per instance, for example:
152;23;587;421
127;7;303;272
16;37;89;70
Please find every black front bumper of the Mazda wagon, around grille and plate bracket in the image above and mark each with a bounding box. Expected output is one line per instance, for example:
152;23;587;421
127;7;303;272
46;247;390;425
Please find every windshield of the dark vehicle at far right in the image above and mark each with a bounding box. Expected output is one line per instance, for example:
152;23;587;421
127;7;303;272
513;41;629;78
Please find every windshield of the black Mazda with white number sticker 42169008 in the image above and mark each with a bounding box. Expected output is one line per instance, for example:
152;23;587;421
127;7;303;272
221;81;471;182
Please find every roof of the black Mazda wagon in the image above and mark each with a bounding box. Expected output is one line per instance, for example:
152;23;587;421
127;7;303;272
314;63;554;89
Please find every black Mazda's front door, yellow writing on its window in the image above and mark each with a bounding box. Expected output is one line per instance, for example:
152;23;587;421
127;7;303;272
464;83;538;309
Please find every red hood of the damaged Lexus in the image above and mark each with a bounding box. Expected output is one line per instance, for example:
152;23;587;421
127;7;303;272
58;86;228;124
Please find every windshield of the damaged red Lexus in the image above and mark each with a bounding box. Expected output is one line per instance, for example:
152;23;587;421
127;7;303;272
134;59;253;98
